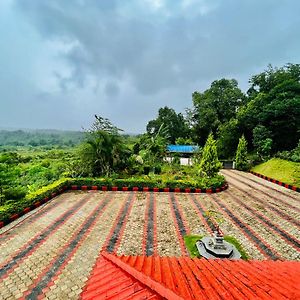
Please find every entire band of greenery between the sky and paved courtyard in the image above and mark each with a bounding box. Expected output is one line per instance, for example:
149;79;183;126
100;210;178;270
0;64;300;209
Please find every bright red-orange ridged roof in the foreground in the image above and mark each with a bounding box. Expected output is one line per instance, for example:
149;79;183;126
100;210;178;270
81;252;300;300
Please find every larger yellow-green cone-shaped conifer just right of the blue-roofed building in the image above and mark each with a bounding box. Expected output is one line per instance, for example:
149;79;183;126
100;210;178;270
199;133;222;178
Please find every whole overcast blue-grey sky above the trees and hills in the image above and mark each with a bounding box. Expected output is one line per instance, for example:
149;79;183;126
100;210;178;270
0;0;300;133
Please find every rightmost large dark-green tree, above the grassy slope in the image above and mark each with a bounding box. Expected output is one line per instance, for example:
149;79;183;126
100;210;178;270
237;64;300;152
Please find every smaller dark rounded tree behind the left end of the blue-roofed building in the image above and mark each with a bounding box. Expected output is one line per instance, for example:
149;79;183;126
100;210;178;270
147;106;189;144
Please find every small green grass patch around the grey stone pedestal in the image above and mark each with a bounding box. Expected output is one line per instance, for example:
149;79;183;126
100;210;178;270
184;234;249;260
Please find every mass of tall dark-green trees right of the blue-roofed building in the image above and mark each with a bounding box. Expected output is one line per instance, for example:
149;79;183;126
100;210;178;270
188;64;300;159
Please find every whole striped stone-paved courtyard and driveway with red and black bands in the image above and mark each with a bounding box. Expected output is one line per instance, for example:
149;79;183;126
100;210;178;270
0;170;300;299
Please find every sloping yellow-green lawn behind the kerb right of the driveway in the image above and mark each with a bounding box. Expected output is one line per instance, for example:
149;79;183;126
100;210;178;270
252;158;300;187
